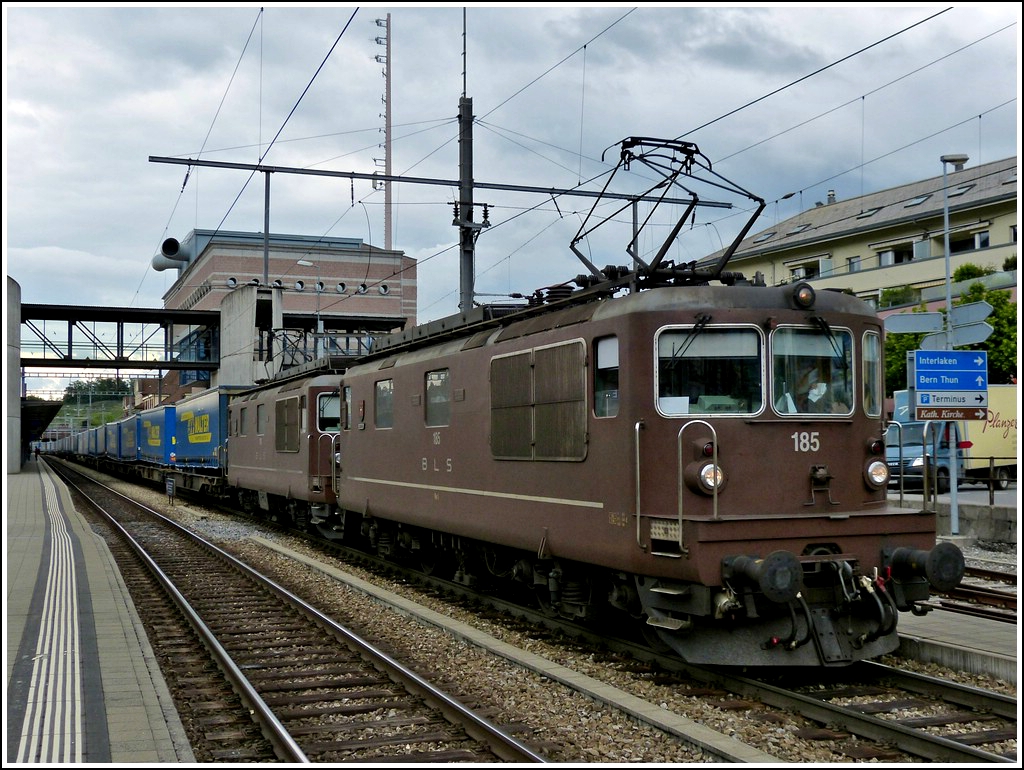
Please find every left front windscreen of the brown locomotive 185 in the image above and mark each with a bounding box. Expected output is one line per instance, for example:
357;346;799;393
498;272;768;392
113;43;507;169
655;327;764;417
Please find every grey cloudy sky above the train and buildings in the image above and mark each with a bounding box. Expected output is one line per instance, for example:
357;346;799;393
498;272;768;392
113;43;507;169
3;3;1021;391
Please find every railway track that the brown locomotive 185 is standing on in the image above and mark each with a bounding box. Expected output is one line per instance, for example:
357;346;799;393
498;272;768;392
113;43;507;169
241;528;1017;763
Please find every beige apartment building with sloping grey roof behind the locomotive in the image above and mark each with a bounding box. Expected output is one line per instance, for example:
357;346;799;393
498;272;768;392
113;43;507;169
702;157;1017;312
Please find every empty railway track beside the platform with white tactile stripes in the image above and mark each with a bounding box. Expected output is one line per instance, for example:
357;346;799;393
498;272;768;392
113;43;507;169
51;460;544;763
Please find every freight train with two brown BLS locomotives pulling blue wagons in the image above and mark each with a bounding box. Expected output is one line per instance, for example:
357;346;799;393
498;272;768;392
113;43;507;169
41;138;964;667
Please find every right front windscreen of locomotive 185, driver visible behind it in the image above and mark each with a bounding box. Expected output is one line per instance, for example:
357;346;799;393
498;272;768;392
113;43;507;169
771;327;854;415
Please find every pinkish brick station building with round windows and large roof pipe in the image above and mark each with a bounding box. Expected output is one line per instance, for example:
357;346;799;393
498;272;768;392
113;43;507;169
136;229;417;410
